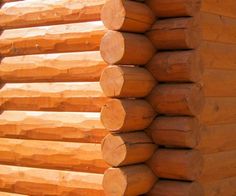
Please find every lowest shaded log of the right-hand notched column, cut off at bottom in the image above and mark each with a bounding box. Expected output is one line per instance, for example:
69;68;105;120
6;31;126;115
147;180;204;196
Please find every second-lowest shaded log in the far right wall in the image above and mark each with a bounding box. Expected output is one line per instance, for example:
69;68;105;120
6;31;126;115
198;149;236;183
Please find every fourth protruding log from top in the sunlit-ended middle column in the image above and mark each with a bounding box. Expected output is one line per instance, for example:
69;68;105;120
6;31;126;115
101;99;155;132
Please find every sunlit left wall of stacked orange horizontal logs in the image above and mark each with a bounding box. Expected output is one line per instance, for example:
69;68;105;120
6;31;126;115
0;0;109;196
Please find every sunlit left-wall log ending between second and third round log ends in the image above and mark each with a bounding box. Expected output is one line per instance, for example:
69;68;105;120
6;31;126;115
0;51;107;83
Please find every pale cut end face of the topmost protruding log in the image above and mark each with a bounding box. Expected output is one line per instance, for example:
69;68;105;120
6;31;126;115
101;0;126;31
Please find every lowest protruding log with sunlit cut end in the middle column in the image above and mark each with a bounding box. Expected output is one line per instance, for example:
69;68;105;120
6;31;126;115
103;165;156;196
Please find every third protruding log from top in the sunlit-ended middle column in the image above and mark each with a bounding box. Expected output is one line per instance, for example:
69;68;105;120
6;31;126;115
100;66;156;98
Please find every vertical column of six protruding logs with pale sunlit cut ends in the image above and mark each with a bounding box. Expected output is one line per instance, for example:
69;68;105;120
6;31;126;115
100;0;157;196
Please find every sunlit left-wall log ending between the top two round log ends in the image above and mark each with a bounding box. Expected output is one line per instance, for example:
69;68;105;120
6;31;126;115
0;21;106;56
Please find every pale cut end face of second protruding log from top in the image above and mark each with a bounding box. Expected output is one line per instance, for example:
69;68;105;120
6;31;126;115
100;31;125;65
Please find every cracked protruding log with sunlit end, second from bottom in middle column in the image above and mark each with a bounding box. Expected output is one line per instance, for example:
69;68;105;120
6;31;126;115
102;132;156;167
